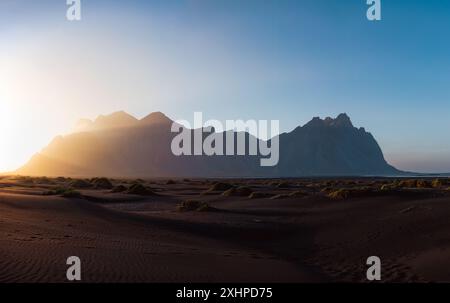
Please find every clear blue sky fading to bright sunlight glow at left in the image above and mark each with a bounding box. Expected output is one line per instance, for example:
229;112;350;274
0;0;450;172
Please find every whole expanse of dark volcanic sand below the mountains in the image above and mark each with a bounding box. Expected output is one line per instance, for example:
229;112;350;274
0;177;450;282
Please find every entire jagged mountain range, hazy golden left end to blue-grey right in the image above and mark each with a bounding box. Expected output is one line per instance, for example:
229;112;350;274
17;112;401;177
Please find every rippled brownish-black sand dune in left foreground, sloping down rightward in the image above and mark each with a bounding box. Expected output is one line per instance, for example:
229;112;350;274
0;194;316;282
